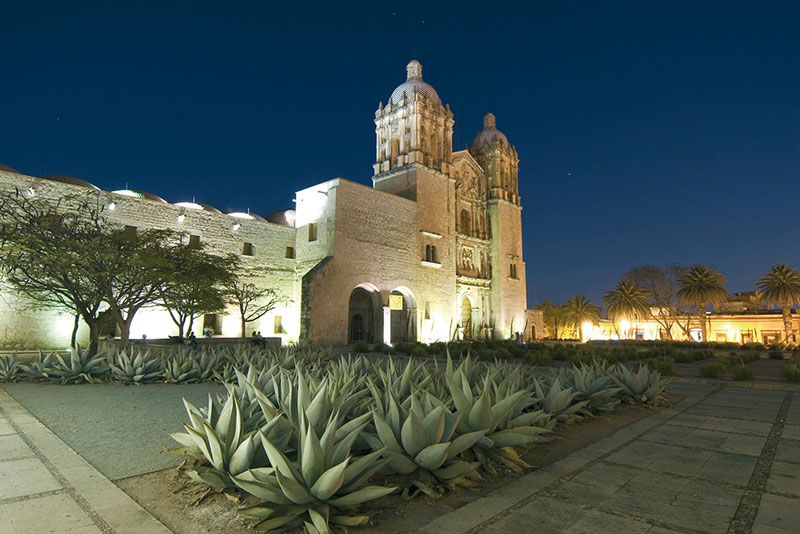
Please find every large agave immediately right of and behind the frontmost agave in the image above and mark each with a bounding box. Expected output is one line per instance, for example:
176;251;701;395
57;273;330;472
364;392;486;498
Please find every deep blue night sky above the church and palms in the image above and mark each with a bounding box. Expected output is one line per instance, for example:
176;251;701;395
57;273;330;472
0;0;800;306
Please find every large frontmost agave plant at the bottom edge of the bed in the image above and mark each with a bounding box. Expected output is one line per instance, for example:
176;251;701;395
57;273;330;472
233;414;396;534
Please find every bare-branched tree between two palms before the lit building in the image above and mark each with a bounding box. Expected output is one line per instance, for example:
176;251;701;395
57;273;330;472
622;263;691;339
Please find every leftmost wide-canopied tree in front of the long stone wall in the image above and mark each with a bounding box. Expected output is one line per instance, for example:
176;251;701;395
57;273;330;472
0;190;109;355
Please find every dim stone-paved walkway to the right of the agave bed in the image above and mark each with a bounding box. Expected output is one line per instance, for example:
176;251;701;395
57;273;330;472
418;384;800;534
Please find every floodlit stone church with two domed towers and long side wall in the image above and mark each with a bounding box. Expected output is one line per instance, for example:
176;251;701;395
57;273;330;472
0;60;534;349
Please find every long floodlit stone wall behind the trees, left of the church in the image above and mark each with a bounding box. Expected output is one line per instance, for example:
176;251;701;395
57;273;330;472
0;171;300;349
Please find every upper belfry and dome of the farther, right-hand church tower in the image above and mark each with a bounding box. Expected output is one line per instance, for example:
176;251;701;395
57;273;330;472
469;113;520;206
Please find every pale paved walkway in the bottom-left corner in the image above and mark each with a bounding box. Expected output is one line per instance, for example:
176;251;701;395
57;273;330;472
0;389;170;534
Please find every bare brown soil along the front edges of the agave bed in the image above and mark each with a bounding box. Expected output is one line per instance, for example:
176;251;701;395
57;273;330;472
116;395;668;534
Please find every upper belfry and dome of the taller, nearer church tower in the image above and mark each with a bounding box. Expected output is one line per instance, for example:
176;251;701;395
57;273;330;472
373;59;454;178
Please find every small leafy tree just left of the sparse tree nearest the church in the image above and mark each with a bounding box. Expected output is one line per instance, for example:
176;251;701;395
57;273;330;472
158;245;239;337
